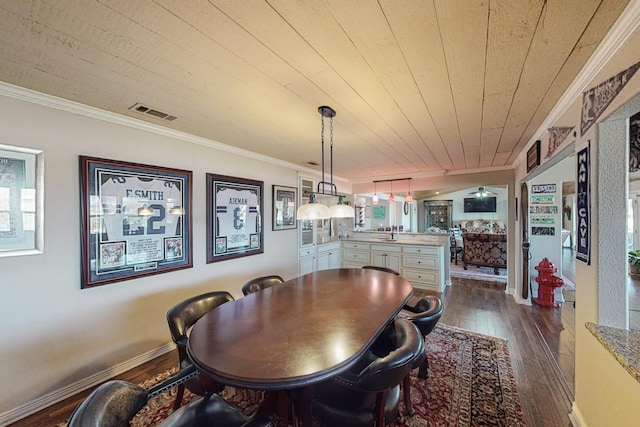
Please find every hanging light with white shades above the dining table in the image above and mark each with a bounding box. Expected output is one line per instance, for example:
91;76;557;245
296;106;355;220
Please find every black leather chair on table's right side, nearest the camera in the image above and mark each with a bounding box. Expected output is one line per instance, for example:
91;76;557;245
312;318;424;427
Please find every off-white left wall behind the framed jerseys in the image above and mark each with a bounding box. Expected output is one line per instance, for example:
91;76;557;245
0;88;297;424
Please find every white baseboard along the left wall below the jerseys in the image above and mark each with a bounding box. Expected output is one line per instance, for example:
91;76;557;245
0;342;177;426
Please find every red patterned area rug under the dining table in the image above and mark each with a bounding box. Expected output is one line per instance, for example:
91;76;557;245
60;324;525;427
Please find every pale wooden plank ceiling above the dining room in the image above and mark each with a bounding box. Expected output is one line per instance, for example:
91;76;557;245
0;0;628;180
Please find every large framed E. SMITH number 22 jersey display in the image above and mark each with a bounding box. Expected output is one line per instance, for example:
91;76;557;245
80;156;193;288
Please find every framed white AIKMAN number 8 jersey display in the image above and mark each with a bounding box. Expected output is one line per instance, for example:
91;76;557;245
207;173;264;263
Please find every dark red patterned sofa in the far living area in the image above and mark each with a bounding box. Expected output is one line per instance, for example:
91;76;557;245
459;220;507;274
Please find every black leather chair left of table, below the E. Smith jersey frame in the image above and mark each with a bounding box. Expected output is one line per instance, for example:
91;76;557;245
167;291;234;409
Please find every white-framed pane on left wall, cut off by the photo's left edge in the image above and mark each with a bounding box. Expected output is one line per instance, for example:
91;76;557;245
0;145;44;256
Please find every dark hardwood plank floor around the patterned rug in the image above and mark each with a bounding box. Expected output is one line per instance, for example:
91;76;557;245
12;279;574;427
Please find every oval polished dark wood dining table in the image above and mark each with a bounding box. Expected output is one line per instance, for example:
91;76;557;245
187;268;413;426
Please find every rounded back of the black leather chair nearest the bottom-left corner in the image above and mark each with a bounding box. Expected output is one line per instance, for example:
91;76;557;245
68;380;147;427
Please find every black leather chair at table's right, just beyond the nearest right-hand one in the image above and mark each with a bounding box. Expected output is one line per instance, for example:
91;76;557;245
399;295;444;415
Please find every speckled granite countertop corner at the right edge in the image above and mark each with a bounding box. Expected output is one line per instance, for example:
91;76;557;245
585;322;640;382
